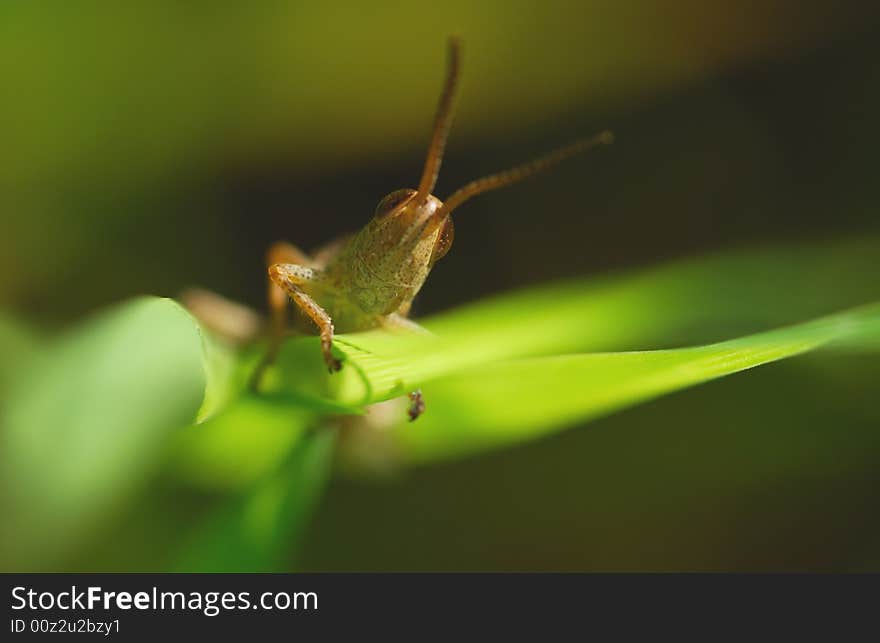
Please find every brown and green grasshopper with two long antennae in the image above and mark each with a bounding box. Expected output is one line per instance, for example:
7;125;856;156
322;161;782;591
253;38;613;419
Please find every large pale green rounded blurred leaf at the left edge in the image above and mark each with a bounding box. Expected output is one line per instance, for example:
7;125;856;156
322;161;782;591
0;298;205;569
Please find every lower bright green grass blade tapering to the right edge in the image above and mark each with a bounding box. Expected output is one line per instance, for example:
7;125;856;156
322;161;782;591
393;305;880;462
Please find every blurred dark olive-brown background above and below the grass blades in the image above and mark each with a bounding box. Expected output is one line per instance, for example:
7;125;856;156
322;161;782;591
0;0;880;570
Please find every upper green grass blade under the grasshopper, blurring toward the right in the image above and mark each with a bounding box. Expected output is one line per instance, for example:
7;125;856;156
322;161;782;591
324;239;880;404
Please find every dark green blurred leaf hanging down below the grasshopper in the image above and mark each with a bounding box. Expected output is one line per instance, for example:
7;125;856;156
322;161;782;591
178;427;335;572
